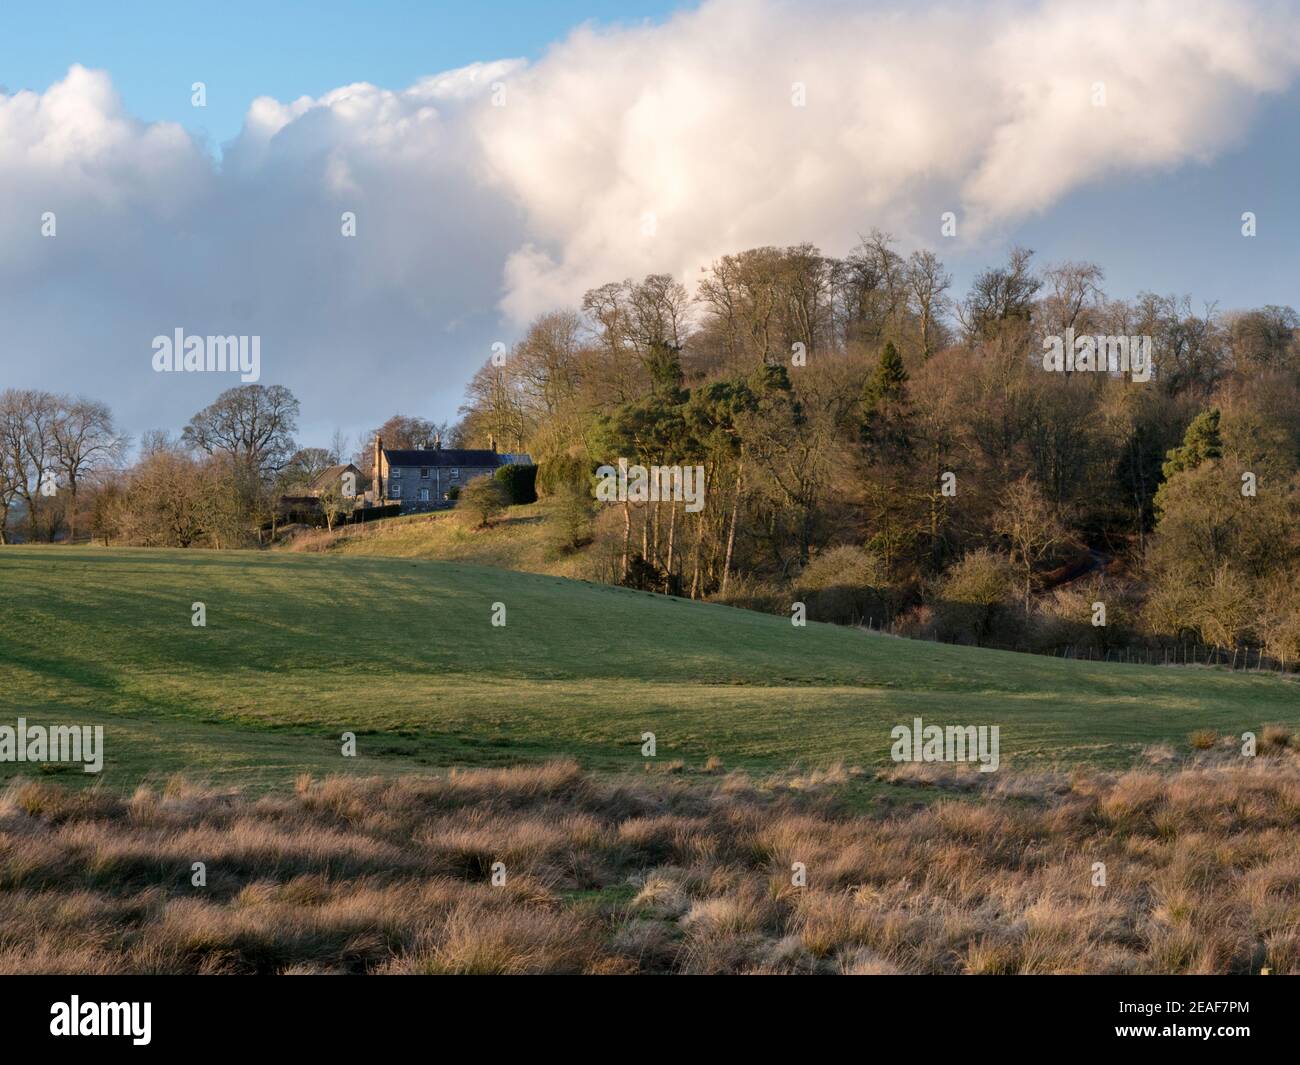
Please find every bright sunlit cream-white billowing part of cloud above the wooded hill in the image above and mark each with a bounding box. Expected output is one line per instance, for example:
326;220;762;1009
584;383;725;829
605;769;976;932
476;0;1300;317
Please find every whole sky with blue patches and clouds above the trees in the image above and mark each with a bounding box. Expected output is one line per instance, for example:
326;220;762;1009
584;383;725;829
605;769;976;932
0;0;1300;445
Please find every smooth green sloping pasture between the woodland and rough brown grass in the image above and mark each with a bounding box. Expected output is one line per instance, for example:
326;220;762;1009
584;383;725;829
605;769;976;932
0;546;1300;787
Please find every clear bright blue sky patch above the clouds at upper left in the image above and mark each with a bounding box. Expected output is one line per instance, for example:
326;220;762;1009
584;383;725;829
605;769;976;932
0;0;689;150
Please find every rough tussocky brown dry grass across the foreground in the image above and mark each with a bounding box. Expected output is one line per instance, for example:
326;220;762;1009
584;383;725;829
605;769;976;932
0;759;1300;974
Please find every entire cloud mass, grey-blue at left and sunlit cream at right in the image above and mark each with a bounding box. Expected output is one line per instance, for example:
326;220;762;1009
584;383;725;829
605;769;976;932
0;0;1300;439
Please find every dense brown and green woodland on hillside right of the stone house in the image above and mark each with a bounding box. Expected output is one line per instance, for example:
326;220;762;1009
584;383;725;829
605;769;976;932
458;233;1300;658
